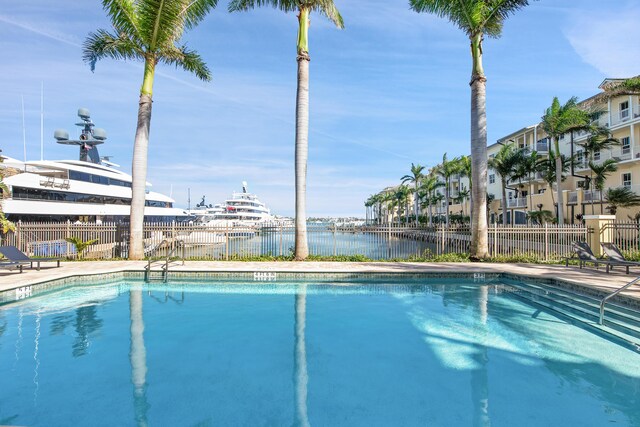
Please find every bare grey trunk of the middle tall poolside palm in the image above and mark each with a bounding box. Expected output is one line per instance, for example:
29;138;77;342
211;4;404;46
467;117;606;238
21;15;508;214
295;8;310;261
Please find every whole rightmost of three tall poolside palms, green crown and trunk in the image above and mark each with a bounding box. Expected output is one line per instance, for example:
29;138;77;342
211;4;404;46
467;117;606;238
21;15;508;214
409;0;529;259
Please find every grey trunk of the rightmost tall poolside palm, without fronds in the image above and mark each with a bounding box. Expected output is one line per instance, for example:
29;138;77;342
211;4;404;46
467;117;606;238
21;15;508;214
469;33;489;259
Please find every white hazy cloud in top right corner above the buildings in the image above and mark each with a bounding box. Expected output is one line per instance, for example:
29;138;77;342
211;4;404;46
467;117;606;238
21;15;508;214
565;7;640;77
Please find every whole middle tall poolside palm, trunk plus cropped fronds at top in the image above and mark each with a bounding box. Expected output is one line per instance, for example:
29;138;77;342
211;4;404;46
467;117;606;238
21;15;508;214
229;0;344;261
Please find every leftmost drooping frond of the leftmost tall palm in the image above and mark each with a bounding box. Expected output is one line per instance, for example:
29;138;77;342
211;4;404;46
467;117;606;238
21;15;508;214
82;30;145;71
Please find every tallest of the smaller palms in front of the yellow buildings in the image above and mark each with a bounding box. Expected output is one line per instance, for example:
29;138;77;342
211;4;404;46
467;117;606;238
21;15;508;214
542;97;591;224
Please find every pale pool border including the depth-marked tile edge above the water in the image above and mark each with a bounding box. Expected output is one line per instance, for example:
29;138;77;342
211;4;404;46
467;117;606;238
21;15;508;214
0;261;640;309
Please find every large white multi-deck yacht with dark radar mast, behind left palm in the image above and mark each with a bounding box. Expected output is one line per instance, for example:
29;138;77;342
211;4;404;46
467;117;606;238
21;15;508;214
2;108;187;223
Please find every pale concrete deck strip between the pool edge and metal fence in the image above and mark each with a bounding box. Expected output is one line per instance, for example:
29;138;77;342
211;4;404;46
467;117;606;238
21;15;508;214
0;261;640;300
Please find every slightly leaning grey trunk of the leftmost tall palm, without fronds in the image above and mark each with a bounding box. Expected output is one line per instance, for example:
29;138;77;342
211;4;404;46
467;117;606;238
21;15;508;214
129;58;155;260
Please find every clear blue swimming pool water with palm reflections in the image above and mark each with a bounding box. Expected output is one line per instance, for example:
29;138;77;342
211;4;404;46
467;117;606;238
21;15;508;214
0;279;640;427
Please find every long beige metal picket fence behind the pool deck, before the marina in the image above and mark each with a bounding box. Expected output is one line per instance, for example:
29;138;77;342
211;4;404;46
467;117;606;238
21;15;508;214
3;223;592;260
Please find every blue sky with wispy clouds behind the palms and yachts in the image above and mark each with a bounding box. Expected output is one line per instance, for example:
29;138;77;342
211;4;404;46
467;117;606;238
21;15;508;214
0;0;640;217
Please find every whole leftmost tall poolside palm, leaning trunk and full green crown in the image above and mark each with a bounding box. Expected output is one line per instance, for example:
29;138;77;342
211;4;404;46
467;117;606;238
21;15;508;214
82;0;217;259
